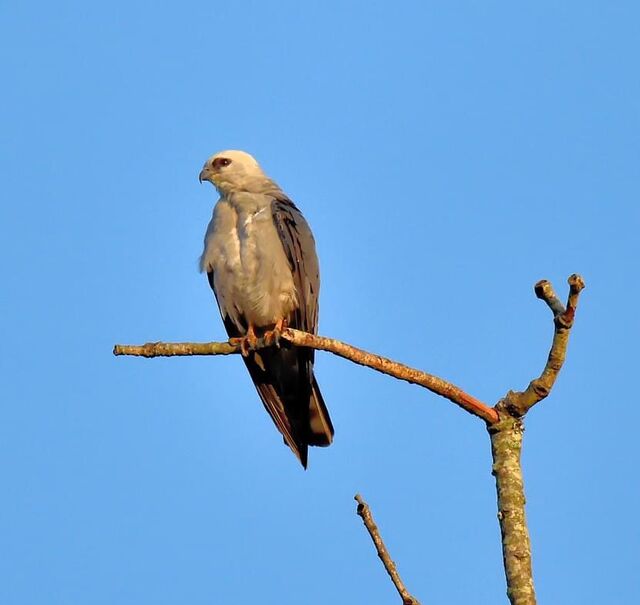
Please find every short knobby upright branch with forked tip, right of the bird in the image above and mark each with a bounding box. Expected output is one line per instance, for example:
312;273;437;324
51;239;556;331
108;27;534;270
496;274;584;417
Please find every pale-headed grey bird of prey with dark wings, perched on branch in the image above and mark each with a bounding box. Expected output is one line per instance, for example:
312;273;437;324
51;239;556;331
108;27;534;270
199;150;334;469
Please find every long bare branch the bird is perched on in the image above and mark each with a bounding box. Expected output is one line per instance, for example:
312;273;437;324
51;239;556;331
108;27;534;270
113;328;498;423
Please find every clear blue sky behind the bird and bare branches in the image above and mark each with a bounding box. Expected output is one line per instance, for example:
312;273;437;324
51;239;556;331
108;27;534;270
0;0;640;605
